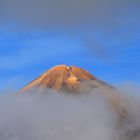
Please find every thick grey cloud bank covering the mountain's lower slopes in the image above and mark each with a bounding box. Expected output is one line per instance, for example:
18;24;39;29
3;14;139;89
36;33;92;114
0;87;140;140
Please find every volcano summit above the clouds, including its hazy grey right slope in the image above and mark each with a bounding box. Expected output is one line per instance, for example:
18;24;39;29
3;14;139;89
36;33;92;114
22;65;112;92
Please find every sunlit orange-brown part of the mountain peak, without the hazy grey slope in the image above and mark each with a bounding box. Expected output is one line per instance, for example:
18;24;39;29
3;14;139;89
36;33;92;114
22;65;96;91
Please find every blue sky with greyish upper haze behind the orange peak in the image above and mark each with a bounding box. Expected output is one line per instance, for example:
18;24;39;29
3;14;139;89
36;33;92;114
0;0;140;90
